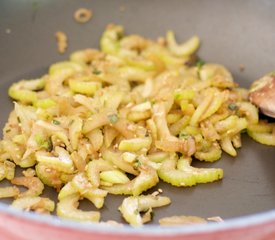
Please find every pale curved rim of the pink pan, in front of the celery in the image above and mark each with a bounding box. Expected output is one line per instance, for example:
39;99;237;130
0;203;275;236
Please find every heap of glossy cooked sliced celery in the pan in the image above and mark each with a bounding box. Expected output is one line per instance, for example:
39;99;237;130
0;25;275;226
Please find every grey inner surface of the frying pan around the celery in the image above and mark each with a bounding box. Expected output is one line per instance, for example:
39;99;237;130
0;0;275;223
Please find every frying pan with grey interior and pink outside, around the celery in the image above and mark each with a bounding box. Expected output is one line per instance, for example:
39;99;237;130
0;0;275;240
